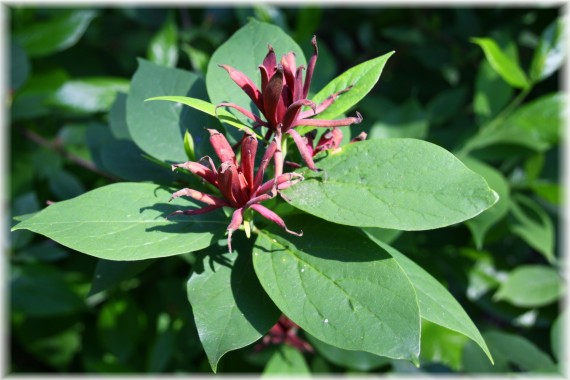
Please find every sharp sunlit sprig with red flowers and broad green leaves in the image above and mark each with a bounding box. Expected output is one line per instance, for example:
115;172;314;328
13;10;554;372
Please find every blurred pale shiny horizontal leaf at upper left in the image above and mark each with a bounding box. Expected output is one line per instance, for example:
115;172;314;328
47;77;129;113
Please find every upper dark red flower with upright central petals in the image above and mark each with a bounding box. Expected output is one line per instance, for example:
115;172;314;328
218;37;362;172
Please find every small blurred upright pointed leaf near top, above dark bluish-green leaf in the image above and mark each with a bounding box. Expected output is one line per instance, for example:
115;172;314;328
147;17;178;67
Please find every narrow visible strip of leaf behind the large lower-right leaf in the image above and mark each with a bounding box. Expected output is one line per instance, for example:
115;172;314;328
372;238;493;362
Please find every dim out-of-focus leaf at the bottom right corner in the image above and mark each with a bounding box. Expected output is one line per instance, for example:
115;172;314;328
463;331;553;373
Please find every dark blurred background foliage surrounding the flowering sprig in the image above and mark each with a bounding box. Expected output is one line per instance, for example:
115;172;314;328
5;4;560;373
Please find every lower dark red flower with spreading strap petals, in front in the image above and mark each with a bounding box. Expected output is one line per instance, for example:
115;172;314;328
170;129;303;252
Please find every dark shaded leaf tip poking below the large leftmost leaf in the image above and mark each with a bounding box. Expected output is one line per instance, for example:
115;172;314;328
89;259;154;296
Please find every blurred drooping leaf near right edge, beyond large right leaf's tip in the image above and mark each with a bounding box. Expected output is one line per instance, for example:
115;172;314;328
510;194;556;263
